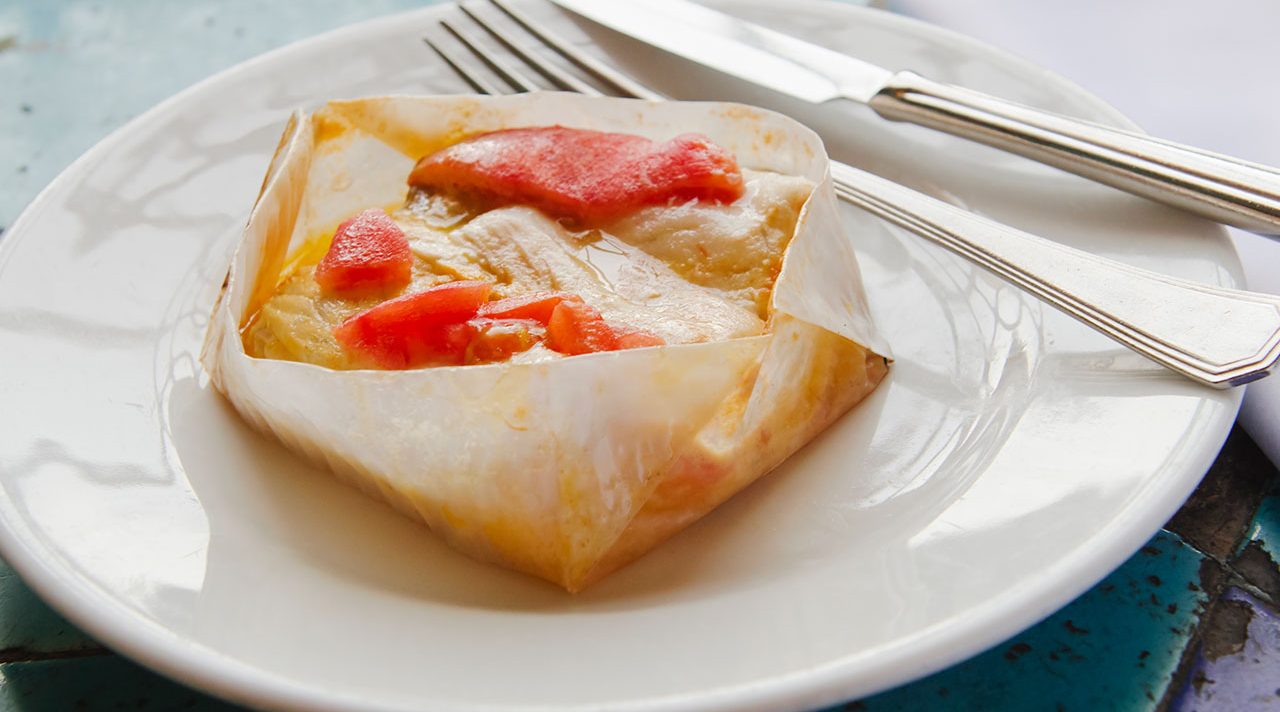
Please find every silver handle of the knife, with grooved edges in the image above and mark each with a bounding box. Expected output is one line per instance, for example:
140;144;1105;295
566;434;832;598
869;72;1280;237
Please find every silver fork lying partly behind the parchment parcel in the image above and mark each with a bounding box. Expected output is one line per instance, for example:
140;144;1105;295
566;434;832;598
424;0;1280;388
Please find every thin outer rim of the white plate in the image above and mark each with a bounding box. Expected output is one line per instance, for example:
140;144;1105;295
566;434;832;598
0;0;1243;712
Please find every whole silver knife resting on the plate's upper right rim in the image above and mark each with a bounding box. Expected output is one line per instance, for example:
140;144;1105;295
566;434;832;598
552;0;1280;237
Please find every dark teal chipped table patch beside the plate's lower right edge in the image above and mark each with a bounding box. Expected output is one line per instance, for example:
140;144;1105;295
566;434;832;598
845;531;1208;712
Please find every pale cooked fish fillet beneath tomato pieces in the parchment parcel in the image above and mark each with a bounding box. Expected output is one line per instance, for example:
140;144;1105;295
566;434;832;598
244;170;813;369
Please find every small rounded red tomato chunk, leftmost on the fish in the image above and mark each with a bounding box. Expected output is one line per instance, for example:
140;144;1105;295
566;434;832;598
315;209;413;296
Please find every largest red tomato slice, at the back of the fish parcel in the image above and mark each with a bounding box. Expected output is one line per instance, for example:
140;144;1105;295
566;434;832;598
408;125;742;223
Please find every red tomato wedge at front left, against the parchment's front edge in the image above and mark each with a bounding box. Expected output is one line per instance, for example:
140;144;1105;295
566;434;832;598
333;282;490;369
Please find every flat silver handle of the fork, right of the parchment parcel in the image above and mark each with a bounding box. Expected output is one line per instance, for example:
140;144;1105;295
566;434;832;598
832;163;1280;388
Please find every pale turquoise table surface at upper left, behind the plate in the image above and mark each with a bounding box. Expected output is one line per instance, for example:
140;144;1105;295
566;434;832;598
0;0;435;227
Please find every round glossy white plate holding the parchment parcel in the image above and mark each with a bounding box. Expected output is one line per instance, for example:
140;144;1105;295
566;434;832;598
0;1;1240;709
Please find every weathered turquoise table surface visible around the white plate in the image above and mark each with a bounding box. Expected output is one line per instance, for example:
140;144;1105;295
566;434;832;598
0;0;1280;711
